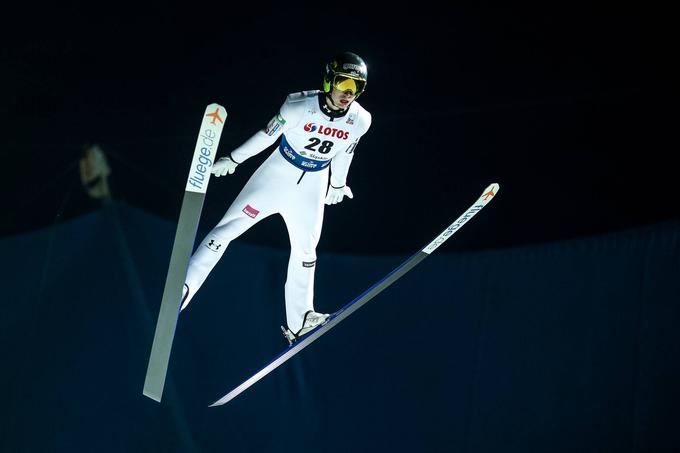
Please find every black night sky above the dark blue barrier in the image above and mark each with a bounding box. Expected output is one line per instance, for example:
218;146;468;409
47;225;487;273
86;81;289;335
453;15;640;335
1;4;678;253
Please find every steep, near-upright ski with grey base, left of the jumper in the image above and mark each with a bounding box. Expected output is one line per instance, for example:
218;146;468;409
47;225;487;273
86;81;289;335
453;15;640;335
143;104;227;402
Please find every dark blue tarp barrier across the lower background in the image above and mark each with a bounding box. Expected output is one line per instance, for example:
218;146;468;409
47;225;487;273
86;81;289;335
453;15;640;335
0;202;680;453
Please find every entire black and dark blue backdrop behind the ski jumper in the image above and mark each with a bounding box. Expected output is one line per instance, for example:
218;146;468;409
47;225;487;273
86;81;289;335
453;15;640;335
0;2;680;452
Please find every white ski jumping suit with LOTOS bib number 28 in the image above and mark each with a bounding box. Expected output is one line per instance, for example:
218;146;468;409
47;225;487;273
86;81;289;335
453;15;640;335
185;91;371;332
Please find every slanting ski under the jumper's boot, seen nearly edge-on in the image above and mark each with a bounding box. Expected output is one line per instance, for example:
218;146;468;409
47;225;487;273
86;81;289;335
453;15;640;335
210;183;499;407
